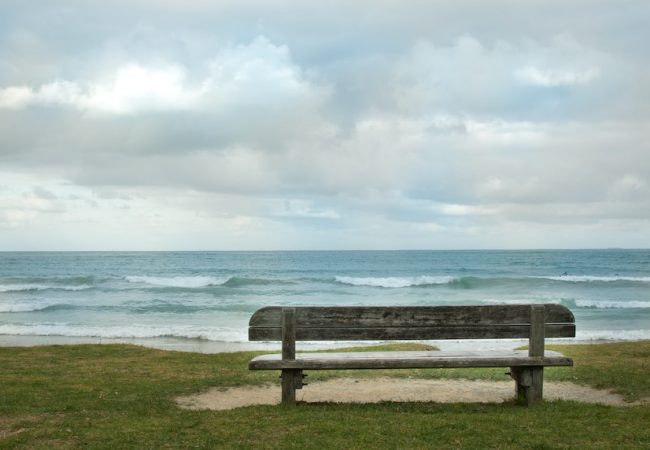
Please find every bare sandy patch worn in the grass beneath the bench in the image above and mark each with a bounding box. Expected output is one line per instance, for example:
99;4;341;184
176;378;639;410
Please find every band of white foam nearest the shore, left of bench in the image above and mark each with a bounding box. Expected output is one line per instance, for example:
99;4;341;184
0;323;248;342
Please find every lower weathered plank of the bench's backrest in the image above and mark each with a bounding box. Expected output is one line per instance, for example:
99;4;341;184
248;324;575;341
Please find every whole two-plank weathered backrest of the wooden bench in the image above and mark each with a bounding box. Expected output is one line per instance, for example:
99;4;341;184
248;304;575;341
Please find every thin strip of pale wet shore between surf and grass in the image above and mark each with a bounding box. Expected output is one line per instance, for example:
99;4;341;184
0;335;632;354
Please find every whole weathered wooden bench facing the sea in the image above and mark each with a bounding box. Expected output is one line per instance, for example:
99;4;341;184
248;304;575;406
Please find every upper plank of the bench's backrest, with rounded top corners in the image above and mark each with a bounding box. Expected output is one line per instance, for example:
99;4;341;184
249;304;575;328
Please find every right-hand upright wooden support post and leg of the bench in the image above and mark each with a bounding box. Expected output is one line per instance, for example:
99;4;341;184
510;305;545;406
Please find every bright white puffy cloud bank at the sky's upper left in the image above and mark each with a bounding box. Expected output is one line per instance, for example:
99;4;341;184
0;37;327;115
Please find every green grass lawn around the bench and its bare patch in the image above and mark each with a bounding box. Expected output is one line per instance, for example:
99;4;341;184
0;341;650;449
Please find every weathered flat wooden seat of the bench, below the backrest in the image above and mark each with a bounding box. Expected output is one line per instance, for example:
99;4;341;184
248;350;573;370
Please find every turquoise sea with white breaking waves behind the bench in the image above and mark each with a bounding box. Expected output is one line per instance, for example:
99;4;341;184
0;250;650;342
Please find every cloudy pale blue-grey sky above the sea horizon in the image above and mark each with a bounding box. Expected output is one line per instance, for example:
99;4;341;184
0;0;650;251
